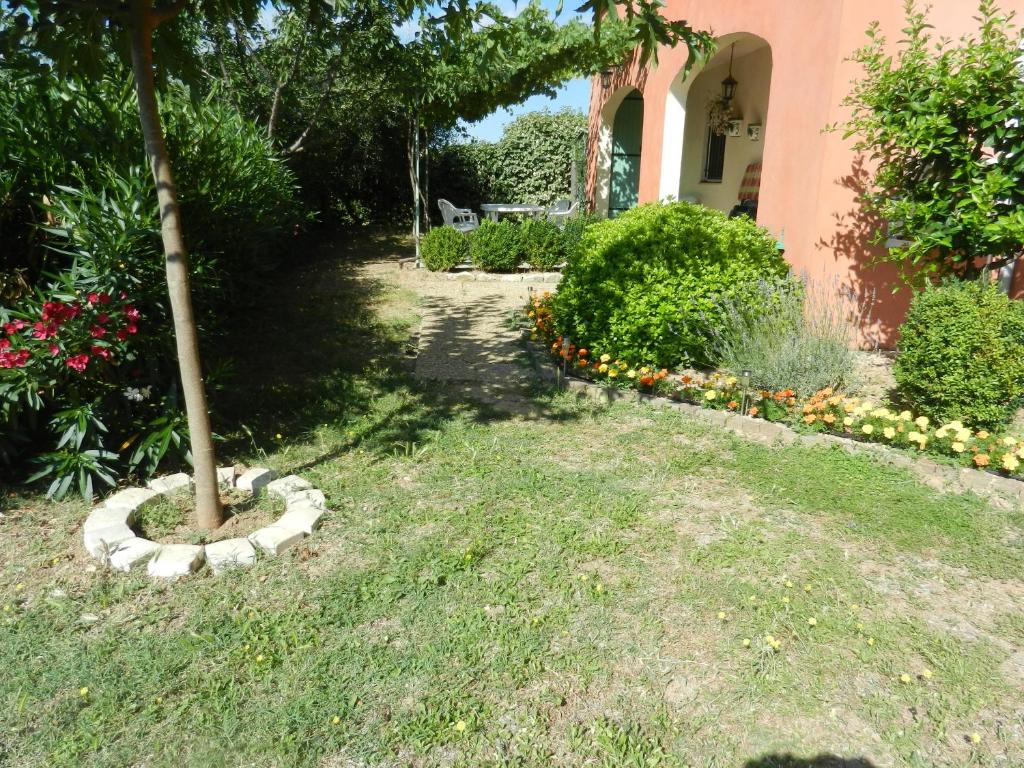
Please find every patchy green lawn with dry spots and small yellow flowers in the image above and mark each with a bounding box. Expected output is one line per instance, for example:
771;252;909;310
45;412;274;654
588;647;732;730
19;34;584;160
0;234;1024;768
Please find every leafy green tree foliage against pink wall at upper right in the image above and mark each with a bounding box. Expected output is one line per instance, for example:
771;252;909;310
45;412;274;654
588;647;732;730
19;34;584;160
845;0;1024;281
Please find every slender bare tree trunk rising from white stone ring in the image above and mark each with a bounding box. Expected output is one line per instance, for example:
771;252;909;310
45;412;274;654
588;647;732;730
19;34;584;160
131;0;223;529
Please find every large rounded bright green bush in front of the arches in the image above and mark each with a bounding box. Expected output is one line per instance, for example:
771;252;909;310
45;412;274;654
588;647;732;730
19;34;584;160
554;203;788;367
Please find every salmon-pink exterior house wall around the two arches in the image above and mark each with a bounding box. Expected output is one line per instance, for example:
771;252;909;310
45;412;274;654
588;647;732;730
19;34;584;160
589;0;1024;346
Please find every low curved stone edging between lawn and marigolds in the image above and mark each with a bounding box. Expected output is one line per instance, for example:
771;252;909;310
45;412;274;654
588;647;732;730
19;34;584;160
525;352;1024;509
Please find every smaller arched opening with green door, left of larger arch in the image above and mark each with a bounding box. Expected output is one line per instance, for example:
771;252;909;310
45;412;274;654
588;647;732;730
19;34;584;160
595;87;643;217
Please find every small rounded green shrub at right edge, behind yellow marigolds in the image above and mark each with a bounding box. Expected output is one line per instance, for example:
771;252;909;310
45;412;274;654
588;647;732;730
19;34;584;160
893;282;1024;429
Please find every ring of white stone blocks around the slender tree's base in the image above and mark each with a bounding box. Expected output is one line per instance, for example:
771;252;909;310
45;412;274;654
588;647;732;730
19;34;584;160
83;467;328;579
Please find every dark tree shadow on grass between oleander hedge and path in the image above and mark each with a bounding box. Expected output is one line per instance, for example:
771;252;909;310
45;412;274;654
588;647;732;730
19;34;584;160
212;225;593;472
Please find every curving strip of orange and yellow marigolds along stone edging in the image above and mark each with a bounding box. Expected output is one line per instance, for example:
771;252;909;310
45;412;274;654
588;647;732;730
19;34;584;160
526;294;1024;479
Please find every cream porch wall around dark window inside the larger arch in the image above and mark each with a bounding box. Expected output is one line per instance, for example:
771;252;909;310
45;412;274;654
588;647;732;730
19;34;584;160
679;46;771;212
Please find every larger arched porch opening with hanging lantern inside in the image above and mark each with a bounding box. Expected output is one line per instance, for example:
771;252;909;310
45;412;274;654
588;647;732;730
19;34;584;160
659;33;772;217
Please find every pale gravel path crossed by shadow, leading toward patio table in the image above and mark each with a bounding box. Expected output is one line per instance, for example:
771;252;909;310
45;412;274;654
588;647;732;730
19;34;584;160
385;266;554;417
